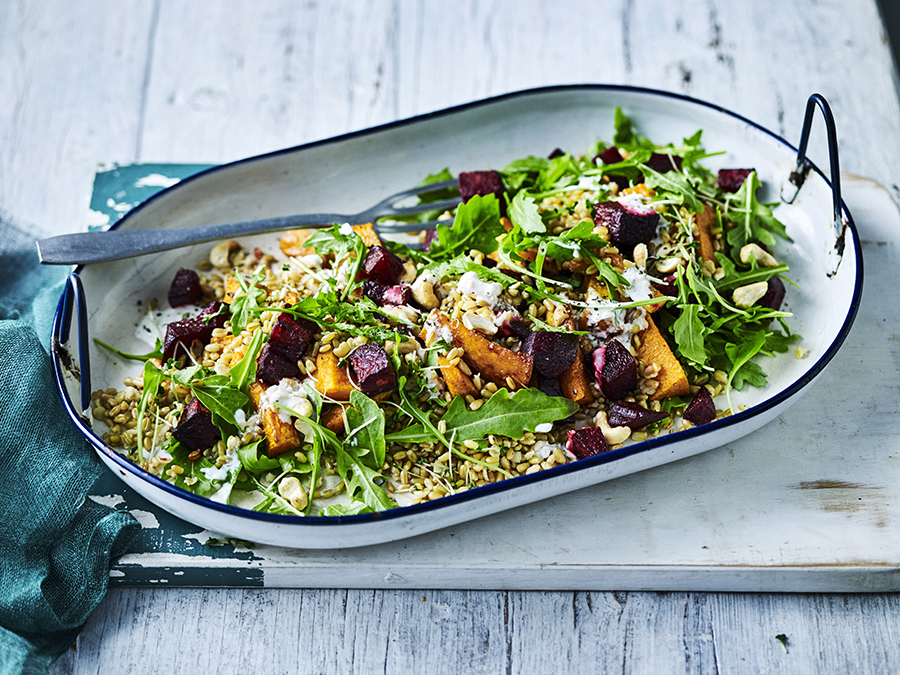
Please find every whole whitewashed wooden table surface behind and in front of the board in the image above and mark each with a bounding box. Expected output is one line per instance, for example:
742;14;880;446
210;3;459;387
0;0;900;674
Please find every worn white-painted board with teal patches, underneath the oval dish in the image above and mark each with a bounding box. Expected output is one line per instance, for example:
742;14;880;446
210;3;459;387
101;174;900;591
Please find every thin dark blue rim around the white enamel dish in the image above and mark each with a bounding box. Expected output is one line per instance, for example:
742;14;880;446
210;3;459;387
52;84;863;527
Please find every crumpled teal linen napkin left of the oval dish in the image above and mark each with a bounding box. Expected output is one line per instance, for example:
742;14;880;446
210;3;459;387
0;217;140;675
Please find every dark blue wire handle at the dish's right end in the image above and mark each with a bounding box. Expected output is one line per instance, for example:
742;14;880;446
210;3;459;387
781;94;847;277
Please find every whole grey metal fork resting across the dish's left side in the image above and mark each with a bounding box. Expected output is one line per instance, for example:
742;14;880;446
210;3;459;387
37;180;460;265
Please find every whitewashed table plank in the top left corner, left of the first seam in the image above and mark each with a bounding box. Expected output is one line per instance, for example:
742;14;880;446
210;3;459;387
0;0;153;233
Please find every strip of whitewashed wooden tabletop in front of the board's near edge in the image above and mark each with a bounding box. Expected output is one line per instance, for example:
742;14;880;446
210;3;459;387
53;589;900;675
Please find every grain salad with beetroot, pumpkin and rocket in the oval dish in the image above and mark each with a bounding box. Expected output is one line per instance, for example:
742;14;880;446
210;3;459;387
91;110;805;516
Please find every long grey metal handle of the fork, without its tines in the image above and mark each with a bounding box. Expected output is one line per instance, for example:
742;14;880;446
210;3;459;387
37;213;354;265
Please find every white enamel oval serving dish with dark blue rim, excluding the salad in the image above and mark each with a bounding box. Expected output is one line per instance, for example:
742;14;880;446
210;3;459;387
53;85;862;548
